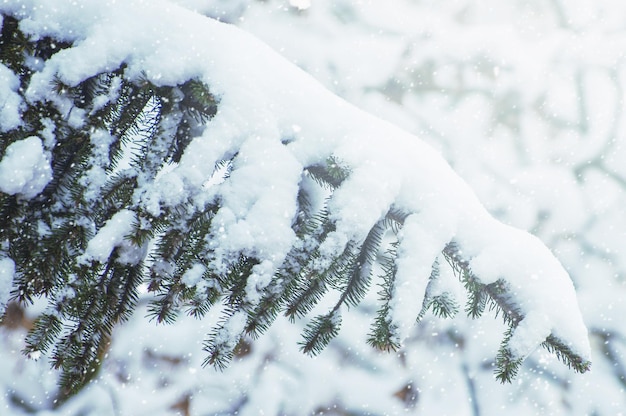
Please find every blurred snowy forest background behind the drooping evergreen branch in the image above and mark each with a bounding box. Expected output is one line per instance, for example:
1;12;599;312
0;0;626;416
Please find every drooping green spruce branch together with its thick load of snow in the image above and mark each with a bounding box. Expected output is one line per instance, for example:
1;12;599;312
0;0;590;392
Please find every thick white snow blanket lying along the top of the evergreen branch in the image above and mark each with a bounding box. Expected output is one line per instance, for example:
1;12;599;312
0;0;590;359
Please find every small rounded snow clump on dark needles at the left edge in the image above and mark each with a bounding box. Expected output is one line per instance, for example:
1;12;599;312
0;136;52;199
